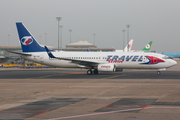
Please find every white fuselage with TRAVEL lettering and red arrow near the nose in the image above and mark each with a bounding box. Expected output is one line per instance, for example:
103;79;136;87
22;52;177;69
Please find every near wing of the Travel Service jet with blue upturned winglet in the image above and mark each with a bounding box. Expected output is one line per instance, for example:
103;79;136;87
44;46;99;67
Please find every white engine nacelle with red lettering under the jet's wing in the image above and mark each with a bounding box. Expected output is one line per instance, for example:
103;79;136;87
97;63;116;72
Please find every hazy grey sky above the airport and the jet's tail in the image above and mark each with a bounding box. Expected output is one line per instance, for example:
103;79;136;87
0;0;180;52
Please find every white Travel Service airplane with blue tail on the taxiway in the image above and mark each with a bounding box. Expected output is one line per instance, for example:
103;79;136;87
11;22;177;75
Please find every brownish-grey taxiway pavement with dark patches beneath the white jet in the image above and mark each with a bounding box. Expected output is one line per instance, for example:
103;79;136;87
0;60;180;120
